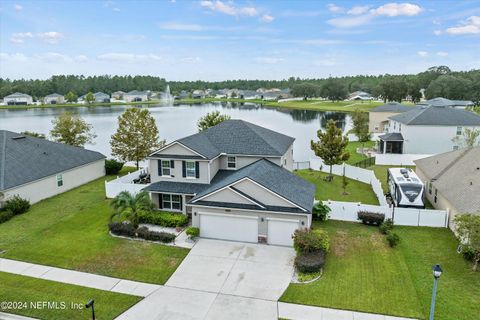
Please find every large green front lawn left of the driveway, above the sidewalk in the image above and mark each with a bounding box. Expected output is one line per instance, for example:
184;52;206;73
0;168;188;284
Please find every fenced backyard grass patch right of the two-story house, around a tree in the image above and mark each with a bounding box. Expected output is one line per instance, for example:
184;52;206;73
295;170;378;204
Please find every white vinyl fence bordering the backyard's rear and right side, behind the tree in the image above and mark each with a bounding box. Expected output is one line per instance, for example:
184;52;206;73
294;158;388;206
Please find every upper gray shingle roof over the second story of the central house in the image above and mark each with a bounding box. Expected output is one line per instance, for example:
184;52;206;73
177;120;295;159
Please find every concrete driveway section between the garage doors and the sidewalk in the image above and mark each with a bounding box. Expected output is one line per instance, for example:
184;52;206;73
166;239;295;301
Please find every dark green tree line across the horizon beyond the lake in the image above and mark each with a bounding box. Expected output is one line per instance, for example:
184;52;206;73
0;66;480;104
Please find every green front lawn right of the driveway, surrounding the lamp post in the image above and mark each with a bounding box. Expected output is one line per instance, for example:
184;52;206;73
280;220;480;320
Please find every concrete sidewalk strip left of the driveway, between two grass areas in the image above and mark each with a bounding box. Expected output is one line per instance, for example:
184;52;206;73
0;258;161;297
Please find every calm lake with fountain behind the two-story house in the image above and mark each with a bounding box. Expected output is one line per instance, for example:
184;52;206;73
0;102;352;161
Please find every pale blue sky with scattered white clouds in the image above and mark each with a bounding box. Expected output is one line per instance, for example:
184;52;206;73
0;0;480;80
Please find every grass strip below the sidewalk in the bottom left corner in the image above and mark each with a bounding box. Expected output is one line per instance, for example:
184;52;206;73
0;272;141;320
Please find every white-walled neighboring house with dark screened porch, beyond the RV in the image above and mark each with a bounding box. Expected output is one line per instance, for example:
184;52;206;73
379;106;480;154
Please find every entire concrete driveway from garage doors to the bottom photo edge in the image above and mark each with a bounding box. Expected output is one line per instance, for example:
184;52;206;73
118;239;295;320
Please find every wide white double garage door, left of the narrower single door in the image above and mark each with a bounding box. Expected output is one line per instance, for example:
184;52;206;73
199;212;258;243
